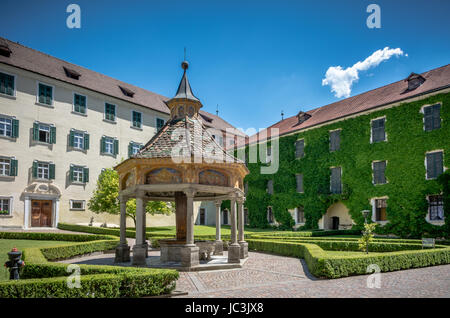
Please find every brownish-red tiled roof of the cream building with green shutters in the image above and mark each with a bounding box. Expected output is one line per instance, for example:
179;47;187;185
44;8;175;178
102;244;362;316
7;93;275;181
0;37;243;134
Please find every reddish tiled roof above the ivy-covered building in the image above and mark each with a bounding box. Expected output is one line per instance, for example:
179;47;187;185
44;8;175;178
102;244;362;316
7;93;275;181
238;64;450;146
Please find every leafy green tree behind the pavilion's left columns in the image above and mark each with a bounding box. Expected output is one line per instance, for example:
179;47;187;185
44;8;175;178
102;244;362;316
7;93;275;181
88;168;174;227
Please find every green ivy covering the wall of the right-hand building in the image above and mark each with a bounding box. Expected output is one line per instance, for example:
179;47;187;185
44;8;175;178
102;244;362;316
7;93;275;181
241;93;450;237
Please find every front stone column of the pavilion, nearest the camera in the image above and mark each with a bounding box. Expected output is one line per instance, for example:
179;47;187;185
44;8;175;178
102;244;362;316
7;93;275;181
180;189;199;270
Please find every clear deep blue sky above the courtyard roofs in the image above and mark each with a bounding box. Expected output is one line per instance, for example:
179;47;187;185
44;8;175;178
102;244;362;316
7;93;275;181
0;0;450;129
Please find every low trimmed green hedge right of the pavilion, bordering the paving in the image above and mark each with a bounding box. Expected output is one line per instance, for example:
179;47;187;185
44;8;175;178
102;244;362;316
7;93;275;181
247;239;450;278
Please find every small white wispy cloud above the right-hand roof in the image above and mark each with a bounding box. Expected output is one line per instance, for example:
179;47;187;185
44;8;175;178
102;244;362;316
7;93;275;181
322;47;408;98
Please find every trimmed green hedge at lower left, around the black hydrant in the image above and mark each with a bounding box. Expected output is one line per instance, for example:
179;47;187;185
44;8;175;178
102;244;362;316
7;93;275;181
0;232;179;298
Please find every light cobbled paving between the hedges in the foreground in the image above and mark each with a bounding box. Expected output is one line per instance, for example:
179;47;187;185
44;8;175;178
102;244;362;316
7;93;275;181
57;251;450;298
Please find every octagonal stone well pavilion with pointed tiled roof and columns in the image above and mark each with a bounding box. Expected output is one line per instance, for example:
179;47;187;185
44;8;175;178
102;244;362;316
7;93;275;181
115;61;249;270
